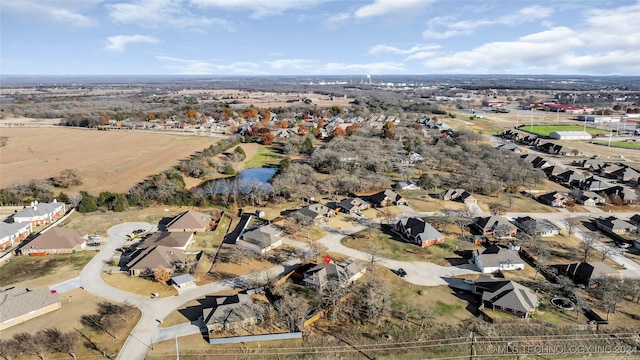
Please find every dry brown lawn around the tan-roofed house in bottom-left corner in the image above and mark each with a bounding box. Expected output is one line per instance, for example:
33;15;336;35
0;289;140;359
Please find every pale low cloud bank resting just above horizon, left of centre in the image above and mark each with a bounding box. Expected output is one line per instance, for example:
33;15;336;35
155;56;266;75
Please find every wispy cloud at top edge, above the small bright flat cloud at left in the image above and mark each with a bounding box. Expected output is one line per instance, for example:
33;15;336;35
107;0;233;31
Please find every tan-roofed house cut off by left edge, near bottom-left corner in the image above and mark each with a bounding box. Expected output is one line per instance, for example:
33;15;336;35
0;286;62;331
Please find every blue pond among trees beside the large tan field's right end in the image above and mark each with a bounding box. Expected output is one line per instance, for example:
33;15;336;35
194;167;278;194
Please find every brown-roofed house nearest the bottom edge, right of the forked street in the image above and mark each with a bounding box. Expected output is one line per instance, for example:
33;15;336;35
202;294;259;333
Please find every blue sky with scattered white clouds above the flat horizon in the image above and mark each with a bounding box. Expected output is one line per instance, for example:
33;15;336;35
0;0;640;75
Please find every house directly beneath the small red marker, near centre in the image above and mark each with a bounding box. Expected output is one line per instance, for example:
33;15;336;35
303;260;367;290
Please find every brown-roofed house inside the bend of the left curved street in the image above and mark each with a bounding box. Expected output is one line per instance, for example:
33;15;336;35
126;245;187;276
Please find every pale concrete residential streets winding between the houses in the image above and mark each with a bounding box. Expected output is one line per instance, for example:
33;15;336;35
70;208;640;360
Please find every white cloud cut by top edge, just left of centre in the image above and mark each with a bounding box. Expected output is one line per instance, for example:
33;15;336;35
190;0;330;19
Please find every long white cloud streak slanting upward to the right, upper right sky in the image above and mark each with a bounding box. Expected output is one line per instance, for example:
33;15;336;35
422;5;553;39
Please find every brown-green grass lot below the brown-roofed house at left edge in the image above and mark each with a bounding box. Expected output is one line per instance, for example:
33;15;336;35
0;251;95;287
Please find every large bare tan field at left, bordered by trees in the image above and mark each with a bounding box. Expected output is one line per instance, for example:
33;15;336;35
0;128;216;193
